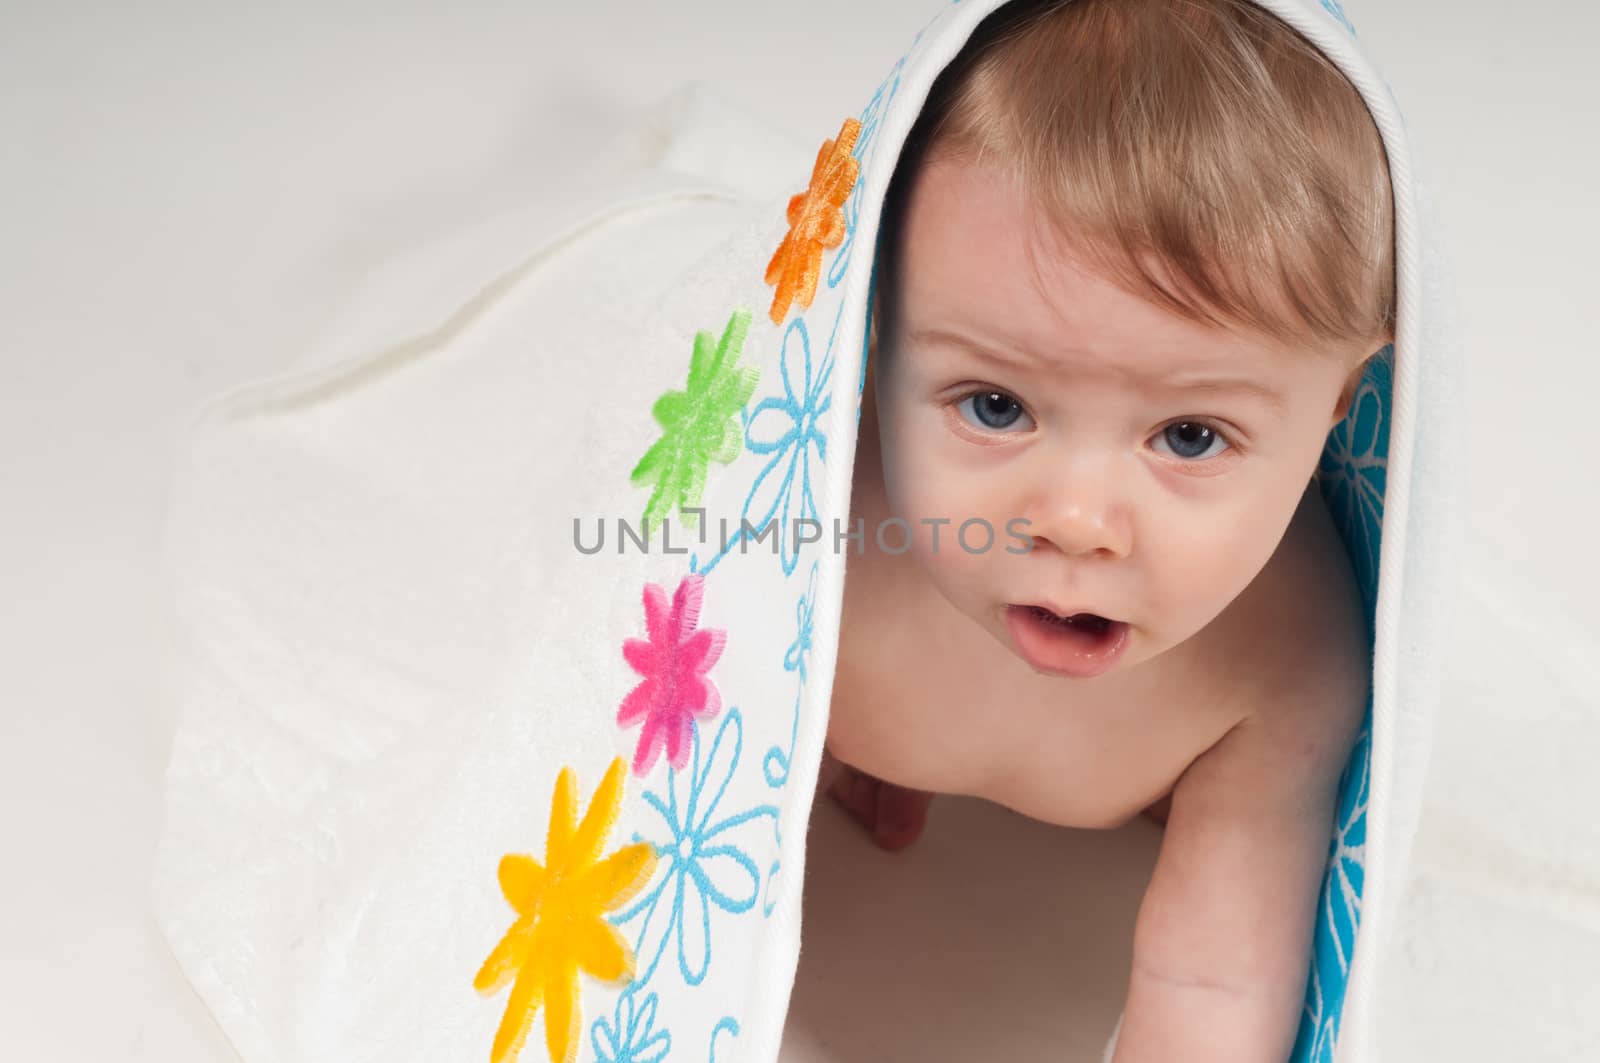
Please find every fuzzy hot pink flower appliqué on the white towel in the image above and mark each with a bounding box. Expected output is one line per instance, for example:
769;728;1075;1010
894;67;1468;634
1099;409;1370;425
616;575;728;775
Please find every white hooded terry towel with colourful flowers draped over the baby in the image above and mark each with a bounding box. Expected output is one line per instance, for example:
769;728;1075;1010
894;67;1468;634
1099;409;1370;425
154;0;1458;1063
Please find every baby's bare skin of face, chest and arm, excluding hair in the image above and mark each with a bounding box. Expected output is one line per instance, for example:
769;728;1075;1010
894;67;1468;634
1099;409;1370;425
821;157;1371;1063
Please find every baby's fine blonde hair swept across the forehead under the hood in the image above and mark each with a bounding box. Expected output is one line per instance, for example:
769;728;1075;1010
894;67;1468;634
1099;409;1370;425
885;0;1395;354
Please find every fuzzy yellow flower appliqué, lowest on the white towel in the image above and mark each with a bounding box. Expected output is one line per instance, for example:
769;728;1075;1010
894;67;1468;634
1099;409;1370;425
472;757;656;1063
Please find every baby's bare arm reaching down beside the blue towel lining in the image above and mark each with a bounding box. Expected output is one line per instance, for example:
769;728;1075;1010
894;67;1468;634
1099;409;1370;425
1114;684;1363;1063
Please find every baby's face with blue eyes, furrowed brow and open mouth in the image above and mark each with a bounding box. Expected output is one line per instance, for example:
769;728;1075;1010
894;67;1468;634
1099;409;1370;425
875;158;1360;677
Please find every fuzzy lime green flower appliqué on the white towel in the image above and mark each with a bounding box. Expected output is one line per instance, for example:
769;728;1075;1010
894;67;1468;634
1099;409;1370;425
629;307;760;533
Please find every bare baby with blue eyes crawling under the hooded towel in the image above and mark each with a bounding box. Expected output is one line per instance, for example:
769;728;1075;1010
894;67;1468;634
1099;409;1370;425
824;0;1394;1063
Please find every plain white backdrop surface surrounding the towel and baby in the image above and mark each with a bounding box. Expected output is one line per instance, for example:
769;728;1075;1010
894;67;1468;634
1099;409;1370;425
0;0;1600;1063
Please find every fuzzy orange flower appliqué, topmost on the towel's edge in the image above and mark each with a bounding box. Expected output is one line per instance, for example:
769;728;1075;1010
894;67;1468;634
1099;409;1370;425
766;118;861;325
